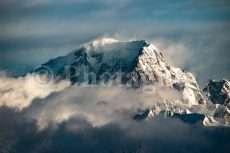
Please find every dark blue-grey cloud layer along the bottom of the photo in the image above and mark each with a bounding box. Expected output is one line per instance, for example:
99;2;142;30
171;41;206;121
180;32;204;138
0;108;230;153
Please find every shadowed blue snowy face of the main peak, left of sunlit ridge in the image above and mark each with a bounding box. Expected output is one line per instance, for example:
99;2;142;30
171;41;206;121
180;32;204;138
43;39;146;84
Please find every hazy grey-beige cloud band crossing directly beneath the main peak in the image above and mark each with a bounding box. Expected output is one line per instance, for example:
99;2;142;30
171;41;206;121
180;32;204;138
22;83;187;130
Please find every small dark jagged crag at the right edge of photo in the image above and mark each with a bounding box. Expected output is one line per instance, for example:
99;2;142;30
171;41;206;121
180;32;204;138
203;79;230;106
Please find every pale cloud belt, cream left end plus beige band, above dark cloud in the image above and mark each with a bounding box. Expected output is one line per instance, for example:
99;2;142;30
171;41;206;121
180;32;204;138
0;70;183;130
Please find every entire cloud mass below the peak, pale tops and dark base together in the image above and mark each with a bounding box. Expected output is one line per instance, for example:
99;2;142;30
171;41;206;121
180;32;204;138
0;72;230;153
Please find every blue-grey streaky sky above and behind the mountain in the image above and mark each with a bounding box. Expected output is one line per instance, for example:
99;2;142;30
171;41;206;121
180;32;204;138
0;0;230;85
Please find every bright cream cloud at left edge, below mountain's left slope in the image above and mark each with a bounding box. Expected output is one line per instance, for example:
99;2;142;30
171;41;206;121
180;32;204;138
0;73;69;110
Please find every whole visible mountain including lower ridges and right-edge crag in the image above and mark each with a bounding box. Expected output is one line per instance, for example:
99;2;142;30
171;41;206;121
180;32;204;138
33;38;229;125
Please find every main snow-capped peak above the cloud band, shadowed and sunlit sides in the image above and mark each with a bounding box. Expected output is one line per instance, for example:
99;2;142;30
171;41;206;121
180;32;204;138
39;39;204;105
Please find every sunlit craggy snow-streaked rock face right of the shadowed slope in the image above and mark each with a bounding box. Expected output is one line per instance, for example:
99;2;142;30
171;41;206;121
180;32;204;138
136;44;199;89
